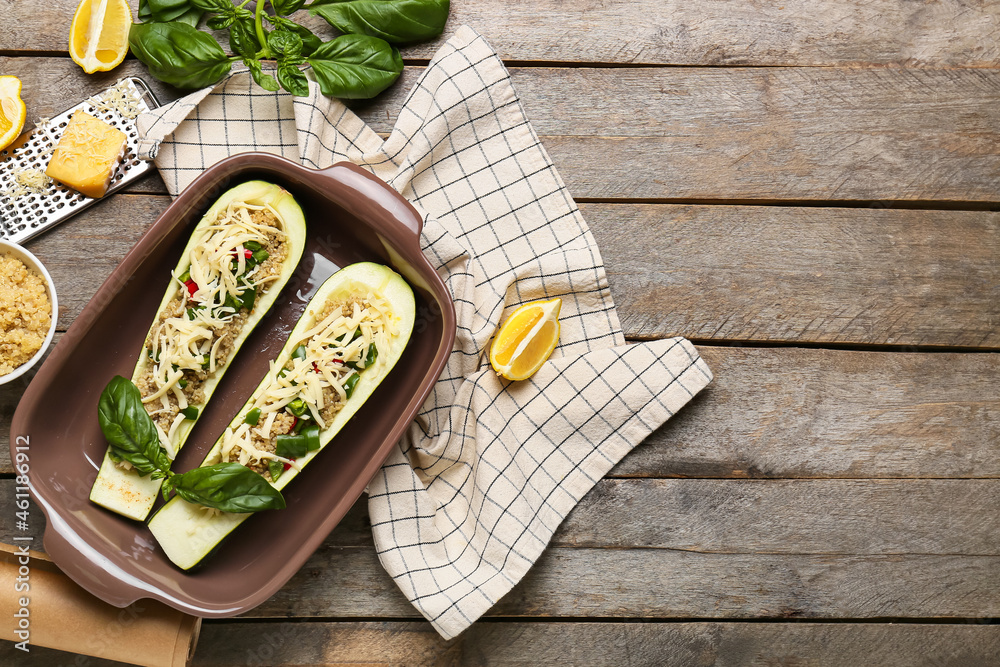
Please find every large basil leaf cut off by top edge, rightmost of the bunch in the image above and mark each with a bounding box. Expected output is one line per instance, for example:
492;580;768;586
309;0;449;44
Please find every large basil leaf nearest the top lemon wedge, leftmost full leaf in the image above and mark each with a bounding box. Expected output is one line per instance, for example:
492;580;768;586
128;21;232;88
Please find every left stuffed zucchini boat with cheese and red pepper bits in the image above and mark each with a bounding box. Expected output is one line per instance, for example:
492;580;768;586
90;181;306;521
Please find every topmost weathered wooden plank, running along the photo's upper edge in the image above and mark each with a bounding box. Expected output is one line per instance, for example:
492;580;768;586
0;0;1000;67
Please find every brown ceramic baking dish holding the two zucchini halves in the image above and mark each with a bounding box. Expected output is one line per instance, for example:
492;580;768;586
11;153;455;617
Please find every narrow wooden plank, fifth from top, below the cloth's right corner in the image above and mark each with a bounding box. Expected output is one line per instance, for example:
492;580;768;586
0;479;1000;556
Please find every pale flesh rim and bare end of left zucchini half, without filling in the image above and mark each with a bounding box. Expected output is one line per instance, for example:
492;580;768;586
90;181;306;521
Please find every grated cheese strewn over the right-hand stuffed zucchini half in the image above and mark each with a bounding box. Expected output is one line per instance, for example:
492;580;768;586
220;292;399;470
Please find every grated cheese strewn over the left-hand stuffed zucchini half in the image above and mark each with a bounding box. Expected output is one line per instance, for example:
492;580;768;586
142;202;285;452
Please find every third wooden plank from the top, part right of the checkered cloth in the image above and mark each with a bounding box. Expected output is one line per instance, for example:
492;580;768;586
581;204;1000;348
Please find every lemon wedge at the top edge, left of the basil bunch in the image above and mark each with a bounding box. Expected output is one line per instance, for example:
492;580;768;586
69;0;132;74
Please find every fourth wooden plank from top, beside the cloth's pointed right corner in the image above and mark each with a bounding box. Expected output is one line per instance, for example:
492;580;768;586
0;347;1000;478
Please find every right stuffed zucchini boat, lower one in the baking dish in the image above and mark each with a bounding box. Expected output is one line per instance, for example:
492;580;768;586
149;262;415;570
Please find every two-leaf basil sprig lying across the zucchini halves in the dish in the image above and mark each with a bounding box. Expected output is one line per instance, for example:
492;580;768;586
97;375;285;512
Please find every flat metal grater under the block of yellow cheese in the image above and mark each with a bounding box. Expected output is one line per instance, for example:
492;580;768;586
0;77;160;243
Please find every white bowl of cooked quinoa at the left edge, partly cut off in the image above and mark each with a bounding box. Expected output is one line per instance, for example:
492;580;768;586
0;241;58;384
